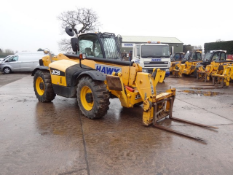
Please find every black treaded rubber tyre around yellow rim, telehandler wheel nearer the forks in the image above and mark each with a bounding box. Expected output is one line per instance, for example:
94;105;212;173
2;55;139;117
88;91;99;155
77;76;110;119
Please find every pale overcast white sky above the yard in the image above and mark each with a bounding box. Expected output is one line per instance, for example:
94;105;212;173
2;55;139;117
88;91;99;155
0;0;233;54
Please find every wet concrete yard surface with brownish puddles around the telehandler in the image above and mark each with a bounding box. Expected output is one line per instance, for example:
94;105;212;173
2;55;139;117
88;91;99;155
0;74;233;175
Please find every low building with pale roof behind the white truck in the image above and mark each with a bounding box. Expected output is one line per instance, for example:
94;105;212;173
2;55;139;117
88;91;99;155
121;36;183;53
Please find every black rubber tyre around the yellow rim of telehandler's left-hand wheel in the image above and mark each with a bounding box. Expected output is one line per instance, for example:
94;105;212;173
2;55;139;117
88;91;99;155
33;70;56;103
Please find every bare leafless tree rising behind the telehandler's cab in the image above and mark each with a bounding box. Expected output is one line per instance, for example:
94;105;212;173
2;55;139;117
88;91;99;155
58;8;100;51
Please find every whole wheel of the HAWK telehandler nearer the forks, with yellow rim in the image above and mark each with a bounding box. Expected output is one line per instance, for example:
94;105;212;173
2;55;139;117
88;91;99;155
77;76;110;119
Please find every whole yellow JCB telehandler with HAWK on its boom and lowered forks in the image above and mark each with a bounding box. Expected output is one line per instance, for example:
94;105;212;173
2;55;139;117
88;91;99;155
32;27;216;141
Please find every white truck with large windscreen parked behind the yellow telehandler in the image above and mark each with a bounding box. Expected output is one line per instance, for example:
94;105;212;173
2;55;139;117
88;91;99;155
132;42;171;77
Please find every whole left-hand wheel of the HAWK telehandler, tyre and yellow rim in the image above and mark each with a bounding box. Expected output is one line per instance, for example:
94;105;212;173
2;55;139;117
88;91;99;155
33;70;56;103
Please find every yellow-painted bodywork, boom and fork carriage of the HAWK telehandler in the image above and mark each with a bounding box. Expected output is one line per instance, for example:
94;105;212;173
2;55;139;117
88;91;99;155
42;54;176;126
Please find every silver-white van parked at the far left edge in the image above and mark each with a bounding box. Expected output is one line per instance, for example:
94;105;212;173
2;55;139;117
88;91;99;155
0;51;45;74
